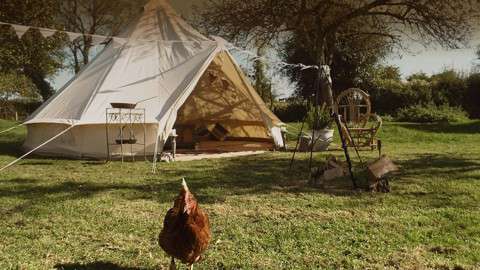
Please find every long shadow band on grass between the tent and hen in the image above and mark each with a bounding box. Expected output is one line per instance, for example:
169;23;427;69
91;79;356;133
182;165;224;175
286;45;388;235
0;155;366;215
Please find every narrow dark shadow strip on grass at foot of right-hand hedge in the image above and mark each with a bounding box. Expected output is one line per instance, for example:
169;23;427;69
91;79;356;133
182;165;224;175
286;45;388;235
396;121;480;134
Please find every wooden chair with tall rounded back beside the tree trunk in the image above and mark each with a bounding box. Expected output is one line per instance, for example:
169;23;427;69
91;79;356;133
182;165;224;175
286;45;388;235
335;88;382;150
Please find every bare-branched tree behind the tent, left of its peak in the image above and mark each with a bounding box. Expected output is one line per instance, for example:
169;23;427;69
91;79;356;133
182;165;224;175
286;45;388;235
59;0;142;73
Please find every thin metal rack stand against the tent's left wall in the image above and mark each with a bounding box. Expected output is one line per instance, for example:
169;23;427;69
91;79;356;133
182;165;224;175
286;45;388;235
105;108;147;162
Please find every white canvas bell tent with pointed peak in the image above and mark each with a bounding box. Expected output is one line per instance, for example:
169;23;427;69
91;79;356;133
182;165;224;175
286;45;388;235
24;0;283;158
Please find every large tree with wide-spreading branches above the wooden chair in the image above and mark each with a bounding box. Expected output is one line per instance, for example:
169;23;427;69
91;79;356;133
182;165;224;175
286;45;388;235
201;0;478;107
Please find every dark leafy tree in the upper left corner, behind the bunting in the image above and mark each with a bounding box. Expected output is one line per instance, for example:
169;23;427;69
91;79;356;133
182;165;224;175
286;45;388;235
0;0;65;100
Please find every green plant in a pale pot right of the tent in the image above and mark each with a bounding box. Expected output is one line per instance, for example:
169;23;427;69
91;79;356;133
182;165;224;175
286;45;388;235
306;103;334;151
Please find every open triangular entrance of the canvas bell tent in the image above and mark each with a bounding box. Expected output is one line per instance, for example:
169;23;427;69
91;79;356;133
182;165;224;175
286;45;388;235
166;52;274;152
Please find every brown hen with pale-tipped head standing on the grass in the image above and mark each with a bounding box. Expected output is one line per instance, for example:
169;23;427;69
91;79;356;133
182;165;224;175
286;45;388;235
158;179;211;270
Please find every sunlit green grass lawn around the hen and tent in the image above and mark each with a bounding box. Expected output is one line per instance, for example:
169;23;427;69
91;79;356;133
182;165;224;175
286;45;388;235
0;121;480;269
